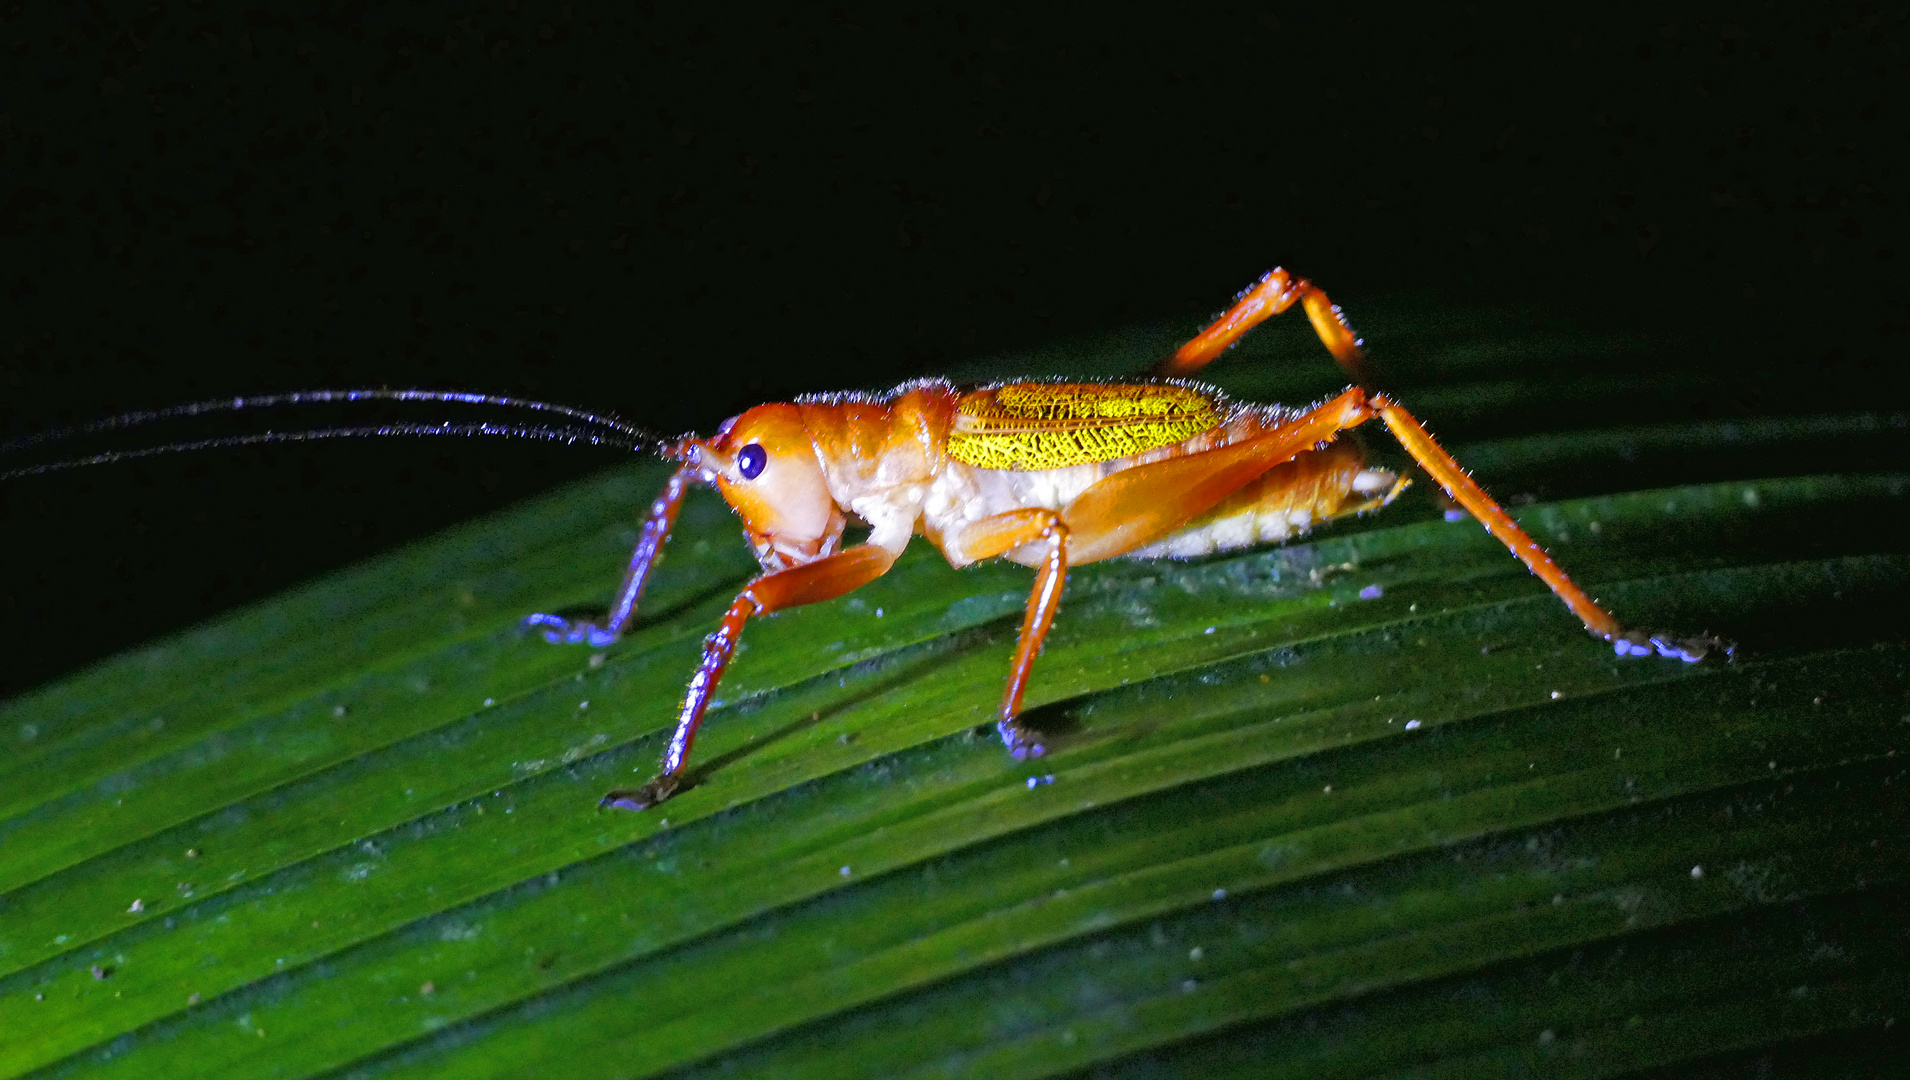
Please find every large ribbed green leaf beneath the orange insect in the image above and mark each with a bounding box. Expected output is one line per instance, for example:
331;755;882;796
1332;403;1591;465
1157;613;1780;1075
0;304;1910;1078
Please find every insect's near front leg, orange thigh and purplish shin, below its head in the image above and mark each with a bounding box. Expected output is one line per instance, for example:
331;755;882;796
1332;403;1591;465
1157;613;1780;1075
598;545;896;810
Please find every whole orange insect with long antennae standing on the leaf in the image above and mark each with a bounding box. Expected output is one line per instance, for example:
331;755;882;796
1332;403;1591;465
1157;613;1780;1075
0;270;1730;810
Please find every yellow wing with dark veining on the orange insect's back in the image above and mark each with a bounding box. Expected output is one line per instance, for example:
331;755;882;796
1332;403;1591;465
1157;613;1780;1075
949;382;1222;470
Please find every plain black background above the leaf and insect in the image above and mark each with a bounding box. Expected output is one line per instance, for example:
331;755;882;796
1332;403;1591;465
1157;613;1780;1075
0;2;1910;694
